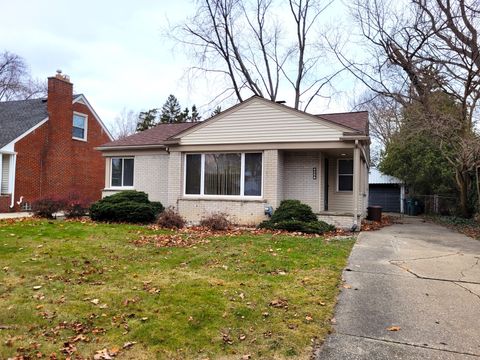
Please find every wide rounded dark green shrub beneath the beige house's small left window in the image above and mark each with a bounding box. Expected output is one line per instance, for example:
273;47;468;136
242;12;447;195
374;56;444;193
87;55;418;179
90;190;163;224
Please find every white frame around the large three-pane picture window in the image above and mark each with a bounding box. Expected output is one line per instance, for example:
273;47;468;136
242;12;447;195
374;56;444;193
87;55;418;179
182;151;264;200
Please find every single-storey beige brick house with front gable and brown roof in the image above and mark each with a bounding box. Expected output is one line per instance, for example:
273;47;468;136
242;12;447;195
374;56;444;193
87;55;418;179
98;96;370;228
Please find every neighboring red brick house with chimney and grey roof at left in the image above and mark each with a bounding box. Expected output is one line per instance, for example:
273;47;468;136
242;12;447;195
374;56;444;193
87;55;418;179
0;73;112;212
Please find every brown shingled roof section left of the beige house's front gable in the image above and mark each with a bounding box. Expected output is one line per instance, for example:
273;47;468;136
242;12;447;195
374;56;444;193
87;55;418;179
101;123;198;147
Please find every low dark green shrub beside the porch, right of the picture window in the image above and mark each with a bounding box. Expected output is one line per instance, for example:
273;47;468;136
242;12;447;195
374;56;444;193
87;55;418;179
258;200;335;234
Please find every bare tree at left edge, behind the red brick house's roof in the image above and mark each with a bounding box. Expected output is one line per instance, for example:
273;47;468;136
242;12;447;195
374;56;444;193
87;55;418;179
0;51;47;101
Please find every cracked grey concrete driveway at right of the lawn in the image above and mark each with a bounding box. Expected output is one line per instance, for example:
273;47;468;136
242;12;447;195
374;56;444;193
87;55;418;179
317;218;480;359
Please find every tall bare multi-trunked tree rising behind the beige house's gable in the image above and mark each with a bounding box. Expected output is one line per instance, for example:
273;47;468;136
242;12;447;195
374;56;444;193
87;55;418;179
173;0;342;110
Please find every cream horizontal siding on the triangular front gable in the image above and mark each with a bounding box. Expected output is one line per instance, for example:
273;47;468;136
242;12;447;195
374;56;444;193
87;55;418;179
181;100;342;145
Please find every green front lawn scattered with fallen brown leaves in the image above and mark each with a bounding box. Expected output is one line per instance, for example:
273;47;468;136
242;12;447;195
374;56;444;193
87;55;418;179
0;220;353;359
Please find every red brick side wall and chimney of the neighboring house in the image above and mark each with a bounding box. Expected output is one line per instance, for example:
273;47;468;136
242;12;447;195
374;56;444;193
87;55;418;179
11;77;110;210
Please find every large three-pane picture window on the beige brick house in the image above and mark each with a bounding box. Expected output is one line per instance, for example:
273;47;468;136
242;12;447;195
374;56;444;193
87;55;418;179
185;153;262;196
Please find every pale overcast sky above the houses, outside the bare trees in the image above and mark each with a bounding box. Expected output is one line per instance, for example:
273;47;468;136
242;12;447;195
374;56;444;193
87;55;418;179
0;0;360;129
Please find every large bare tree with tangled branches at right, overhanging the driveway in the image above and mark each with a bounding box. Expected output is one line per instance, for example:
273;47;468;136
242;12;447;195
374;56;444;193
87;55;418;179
331;0;480;215
